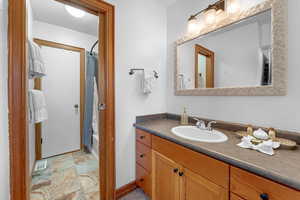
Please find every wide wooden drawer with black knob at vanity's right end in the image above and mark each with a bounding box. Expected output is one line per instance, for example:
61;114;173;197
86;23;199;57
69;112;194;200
230;167;300;200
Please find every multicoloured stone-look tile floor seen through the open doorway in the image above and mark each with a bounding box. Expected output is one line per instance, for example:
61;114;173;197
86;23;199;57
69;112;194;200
31;152;100;200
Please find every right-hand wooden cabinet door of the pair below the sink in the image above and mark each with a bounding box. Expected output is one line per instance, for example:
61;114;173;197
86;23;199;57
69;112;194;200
180;169;229;200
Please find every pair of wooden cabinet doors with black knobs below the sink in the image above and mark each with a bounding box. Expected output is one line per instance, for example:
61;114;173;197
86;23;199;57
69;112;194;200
152;151;228;200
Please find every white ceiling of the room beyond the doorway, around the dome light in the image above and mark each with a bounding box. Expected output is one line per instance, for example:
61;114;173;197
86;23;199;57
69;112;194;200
30;0;98;37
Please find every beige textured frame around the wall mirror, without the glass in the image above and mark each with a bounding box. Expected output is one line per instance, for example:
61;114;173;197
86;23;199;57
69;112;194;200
174;0;288;96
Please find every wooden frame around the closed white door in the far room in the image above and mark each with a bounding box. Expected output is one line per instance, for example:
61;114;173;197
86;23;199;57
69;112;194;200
33;38;86;160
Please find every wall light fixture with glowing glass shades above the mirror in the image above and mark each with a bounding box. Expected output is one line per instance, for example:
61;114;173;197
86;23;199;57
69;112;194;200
188;0;240;34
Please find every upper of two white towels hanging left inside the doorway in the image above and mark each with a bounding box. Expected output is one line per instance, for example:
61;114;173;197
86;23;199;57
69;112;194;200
28;40;46;78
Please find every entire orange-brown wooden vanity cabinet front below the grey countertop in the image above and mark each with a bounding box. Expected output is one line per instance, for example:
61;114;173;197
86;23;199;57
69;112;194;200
136;129;300;200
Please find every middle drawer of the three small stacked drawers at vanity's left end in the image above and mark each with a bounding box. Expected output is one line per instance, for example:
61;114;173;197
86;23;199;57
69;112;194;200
136;142;151;172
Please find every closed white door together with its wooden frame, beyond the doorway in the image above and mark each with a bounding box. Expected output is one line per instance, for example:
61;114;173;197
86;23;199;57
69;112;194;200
34;38;86;160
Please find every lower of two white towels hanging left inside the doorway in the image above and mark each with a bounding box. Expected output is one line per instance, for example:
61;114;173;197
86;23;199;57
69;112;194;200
29;90;48;123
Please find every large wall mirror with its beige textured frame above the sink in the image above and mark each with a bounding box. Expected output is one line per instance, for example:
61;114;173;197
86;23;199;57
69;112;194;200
175;0;288;96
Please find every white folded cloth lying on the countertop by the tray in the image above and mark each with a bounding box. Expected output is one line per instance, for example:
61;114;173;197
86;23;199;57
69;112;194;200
237;136;280;156
